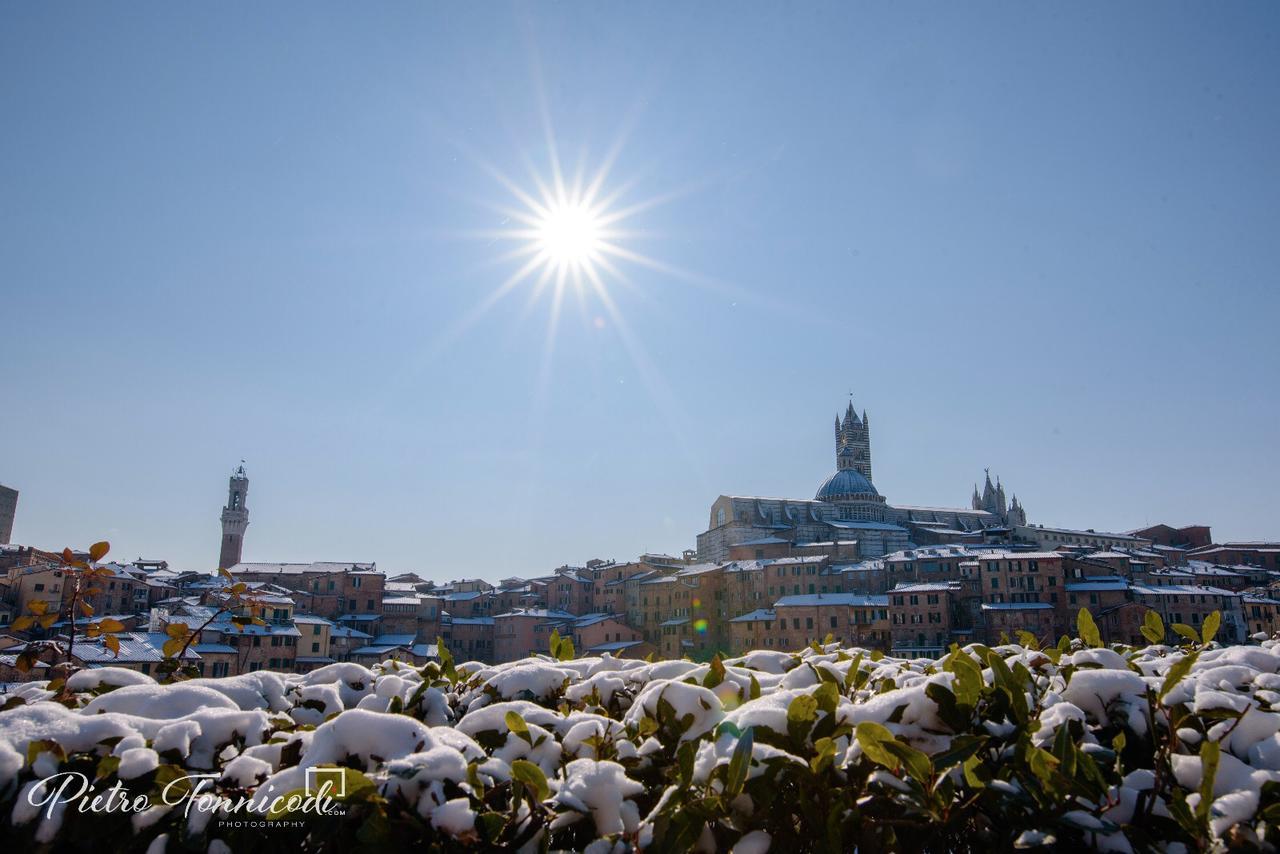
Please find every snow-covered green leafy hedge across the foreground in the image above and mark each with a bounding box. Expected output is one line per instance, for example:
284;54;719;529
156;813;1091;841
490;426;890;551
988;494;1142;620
0;624;1280;853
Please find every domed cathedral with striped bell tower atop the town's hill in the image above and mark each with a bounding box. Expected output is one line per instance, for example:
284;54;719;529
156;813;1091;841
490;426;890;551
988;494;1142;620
698;403;1027;561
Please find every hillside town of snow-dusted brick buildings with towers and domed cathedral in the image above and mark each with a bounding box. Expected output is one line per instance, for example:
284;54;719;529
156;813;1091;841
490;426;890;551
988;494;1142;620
0;405;1280;682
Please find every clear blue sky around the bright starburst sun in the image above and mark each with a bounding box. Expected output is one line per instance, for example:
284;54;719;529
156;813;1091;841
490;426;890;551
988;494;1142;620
0;3;1280;579
